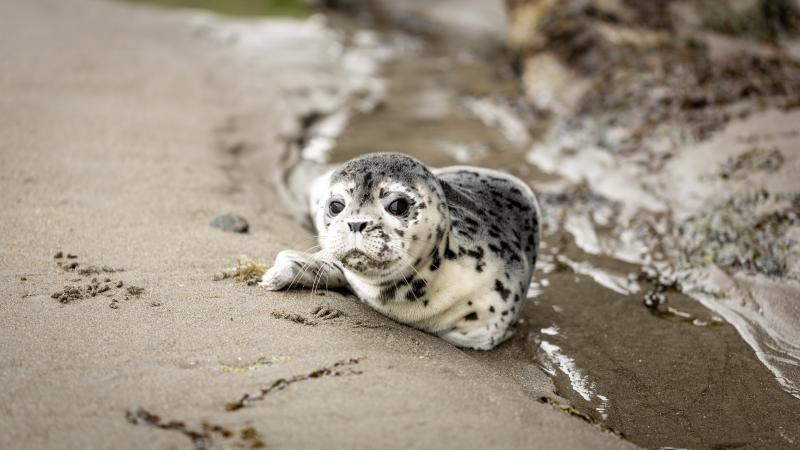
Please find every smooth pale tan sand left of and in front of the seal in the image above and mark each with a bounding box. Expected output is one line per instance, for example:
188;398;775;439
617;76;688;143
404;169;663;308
0;0;630;449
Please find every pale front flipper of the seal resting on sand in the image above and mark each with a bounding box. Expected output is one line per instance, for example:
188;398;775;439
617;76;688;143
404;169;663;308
259;250;347;291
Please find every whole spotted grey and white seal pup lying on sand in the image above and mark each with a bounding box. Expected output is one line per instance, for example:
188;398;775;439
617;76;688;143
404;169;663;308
260;153;540;350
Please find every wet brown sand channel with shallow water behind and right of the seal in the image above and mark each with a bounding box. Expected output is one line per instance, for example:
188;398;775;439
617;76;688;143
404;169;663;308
316;5;800;448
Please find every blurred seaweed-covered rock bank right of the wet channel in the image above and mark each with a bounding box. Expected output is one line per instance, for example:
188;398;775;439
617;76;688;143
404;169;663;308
506;0;800;396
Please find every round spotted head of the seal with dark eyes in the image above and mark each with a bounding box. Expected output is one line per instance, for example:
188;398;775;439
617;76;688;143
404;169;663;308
315;153;449;283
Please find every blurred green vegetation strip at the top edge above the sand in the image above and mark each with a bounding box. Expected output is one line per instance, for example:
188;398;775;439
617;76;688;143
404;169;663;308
125;0;311;17
